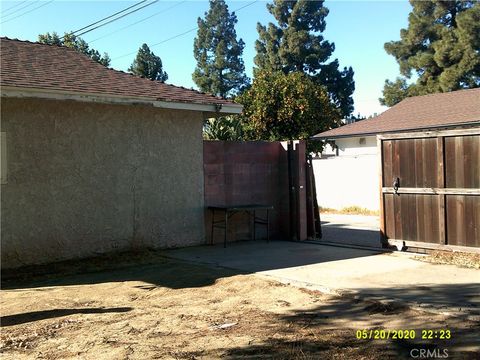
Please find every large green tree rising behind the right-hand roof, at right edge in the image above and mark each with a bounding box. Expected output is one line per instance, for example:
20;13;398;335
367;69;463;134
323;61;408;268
380;0;480;106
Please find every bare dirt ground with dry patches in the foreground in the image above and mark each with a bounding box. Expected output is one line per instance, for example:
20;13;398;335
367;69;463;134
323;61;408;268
0;258;480;360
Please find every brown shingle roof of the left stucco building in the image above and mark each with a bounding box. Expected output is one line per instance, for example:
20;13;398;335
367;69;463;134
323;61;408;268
0;37;239;106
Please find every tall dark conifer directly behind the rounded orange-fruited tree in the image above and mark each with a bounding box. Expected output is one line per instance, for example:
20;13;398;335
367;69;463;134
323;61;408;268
255;0;355;116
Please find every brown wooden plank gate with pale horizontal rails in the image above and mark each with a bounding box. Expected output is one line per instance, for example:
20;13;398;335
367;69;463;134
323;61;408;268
377;127;480;252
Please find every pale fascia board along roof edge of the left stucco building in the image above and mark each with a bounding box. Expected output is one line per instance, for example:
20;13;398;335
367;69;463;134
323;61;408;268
1;86;242;114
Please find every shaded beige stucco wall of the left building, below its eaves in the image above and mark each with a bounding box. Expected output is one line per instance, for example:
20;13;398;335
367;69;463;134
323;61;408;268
1;98;204;268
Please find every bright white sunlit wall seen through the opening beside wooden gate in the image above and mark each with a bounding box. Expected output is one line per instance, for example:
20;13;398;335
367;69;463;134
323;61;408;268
313;136;379;210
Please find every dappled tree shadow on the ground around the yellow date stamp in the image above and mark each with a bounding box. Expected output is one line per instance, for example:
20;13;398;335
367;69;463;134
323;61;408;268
207;284;480;359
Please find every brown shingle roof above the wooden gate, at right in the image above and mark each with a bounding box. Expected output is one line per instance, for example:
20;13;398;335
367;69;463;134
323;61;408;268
315;88;480;138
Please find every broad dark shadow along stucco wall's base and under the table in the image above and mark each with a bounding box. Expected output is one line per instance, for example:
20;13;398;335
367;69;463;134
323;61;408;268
2;232;381;290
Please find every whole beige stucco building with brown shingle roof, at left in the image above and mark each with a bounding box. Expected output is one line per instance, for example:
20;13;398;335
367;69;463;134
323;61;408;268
0;38;241;268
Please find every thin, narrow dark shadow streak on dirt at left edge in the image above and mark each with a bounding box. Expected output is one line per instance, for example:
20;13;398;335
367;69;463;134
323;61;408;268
0;307;133;327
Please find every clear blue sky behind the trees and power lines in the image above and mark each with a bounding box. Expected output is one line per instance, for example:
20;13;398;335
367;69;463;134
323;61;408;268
0;0;411;116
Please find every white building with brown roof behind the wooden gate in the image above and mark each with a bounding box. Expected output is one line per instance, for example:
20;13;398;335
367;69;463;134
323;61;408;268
313;88;480;211
